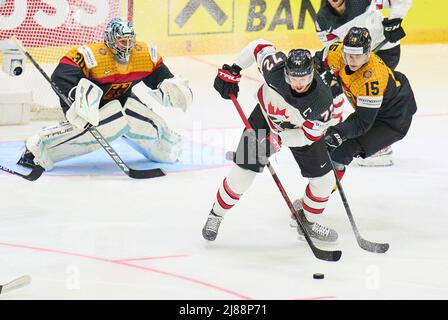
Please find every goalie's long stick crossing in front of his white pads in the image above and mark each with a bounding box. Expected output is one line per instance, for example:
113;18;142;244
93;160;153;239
12;37;166;179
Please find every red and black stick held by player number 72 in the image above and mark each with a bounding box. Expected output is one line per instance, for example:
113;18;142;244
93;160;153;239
230;94;342;261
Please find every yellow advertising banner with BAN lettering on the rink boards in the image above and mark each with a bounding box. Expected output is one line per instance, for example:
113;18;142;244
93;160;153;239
134;0;448;55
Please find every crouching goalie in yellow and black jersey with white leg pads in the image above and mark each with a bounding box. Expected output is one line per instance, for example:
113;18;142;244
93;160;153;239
19;18;192;170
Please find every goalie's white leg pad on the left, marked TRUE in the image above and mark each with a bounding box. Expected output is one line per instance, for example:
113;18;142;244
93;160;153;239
26;100;129;170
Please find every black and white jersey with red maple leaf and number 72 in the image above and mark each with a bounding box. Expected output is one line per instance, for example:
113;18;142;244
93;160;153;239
235;40;342;146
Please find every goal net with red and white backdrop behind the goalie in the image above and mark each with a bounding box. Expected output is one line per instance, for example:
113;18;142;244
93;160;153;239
0;0;135;120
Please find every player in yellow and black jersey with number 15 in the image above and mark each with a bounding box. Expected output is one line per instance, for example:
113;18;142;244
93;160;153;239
323;27;417;170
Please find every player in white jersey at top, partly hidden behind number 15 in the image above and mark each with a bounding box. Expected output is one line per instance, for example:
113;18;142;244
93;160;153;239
316;0;412;166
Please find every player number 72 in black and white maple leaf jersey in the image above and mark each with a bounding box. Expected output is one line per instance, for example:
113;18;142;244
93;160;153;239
202;40;341;242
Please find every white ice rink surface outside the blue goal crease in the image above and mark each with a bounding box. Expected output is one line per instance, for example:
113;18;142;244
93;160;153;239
0;45;448;299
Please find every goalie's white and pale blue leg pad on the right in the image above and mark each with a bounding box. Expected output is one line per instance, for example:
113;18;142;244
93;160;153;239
125;98;182;163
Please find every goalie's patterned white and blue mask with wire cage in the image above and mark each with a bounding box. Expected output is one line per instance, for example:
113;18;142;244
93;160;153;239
104;17;135;63
